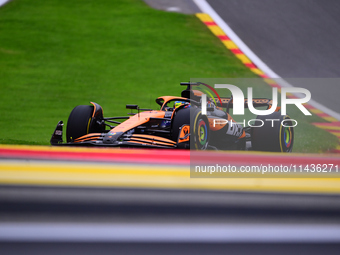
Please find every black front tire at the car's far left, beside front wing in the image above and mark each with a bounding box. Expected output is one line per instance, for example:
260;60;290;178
66;105;94;143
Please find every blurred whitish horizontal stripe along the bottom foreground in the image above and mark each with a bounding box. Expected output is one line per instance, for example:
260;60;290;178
0;223;340;243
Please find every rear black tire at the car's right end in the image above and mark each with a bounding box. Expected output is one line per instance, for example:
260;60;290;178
251;112;294;152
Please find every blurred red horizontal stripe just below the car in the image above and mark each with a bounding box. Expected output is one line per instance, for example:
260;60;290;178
0;148;340;166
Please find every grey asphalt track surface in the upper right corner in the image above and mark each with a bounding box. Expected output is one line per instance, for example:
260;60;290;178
207;0;340;112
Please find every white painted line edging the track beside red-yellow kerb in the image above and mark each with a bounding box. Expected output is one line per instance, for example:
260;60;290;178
193;0;340;120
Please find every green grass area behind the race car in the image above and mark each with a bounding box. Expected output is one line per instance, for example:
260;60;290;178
0;0;335;152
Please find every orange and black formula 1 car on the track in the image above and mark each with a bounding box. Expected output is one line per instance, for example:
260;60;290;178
50;82;294;152
